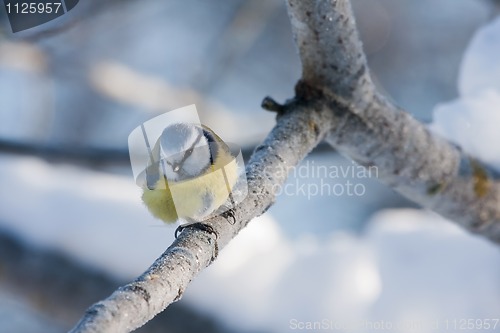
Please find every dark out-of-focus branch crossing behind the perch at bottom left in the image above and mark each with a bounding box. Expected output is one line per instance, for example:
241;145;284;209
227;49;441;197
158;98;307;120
0;228;227;333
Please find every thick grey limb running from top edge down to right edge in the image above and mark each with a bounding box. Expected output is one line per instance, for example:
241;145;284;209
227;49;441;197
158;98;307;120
287;0;500;242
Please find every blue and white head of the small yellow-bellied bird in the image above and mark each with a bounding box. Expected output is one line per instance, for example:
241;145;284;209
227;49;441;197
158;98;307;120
160;123;212;181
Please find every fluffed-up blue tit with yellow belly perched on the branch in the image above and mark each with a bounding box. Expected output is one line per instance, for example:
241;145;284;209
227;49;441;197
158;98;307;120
142;123;238;223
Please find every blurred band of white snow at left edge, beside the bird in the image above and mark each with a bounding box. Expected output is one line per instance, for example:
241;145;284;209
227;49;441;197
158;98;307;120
0;156;173;278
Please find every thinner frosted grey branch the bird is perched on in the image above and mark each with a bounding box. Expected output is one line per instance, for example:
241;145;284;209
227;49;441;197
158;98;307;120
72;101;332;333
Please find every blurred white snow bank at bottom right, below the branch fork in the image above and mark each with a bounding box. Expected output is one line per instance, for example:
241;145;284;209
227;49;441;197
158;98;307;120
185;209;500;332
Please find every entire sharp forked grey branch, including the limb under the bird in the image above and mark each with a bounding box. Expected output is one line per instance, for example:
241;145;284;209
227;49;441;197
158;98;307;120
72;0;500;332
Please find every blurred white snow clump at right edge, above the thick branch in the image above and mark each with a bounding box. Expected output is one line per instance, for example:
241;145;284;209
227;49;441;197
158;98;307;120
430;18;500;170
